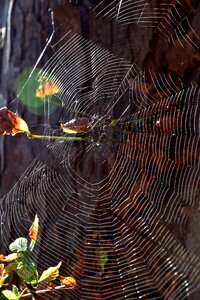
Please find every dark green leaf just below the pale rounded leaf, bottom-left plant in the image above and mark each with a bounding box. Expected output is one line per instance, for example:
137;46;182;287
16;257;38;285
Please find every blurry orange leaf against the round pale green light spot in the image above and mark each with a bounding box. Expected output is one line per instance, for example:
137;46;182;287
35;77;60;98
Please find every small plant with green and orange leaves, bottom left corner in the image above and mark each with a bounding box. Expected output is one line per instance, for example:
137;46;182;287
0;215;76;300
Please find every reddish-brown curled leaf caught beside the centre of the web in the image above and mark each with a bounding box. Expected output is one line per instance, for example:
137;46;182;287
60;117;91;134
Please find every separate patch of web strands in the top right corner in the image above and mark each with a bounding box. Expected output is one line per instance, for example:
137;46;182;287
95;0;200;50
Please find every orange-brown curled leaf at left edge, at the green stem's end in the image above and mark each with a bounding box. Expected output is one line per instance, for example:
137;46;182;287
0;107;29;135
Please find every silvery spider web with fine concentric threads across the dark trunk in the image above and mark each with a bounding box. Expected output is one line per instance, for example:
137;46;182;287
0;0;200;300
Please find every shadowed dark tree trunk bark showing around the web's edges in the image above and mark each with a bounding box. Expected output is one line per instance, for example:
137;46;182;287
0;0;200;300
